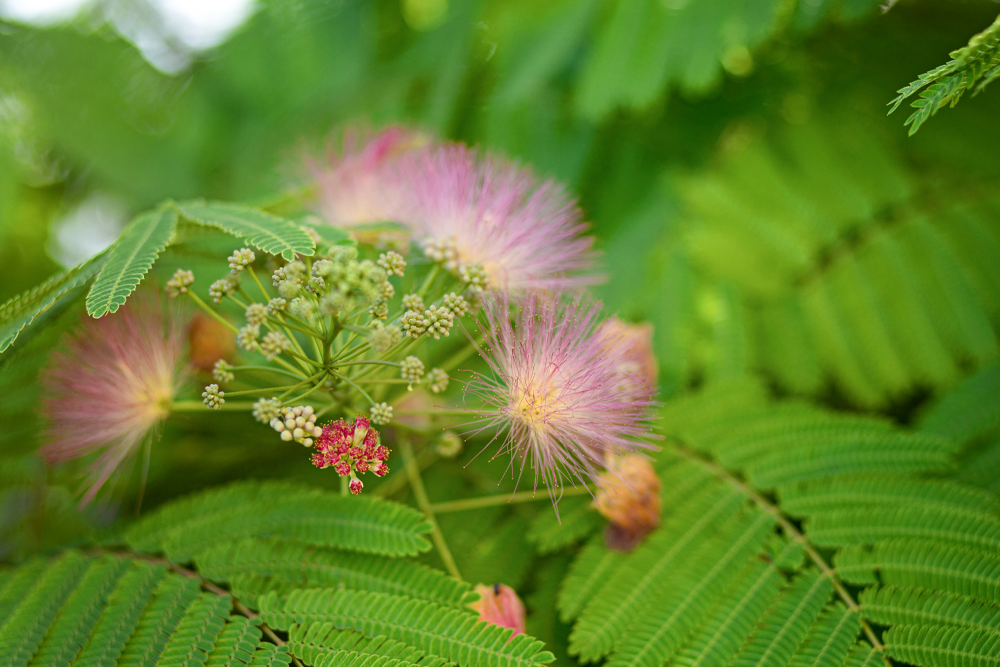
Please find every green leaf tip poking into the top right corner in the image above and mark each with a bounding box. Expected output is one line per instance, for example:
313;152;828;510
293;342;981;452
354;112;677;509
889;16;1000;136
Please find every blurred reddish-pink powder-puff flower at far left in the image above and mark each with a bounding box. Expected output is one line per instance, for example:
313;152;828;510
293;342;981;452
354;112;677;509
39;293;186;504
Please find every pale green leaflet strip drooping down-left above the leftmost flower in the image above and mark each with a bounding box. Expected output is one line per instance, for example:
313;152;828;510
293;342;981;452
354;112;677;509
87;207;177;317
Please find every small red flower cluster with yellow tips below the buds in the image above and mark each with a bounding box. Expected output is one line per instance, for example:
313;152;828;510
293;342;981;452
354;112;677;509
312;415;389;495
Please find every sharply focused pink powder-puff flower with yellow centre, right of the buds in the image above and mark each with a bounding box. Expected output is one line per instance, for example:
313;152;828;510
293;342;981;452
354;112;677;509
466;293;658;513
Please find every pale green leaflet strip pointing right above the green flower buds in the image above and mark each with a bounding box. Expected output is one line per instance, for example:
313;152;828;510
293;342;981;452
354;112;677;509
176;201;316;261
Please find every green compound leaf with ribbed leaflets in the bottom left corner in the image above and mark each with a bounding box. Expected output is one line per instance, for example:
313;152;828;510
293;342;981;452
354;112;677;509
0;551;290;667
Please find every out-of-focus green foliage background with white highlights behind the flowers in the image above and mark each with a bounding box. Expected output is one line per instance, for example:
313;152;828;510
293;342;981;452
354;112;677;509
0;0;1000;636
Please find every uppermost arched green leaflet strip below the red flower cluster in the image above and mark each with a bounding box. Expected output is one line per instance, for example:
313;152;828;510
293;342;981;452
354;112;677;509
125;482;430;562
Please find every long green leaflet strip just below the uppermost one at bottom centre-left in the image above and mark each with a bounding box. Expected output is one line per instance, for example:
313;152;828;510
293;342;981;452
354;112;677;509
196;540;472;605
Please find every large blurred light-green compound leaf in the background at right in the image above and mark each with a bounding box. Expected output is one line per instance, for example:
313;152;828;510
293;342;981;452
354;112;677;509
679;113;1000;408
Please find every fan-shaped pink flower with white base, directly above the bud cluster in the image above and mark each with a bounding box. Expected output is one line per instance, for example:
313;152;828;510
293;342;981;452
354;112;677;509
397;144;598;292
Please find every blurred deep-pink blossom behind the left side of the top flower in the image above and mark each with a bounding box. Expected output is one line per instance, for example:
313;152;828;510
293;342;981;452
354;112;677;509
309;126;427;227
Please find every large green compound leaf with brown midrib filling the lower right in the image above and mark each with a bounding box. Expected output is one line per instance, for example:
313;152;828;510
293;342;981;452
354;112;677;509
559;381;1000;667
